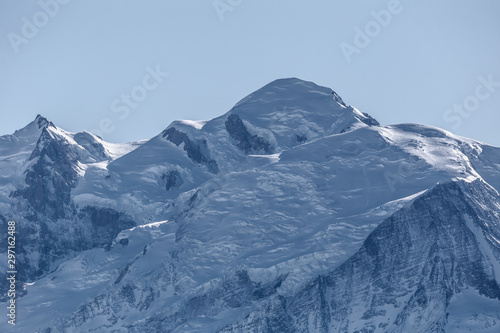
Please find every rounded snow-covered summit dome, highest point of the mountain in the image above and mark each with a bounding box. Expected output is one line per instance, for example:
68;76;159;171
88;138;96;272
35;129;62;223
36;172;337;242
211;78;379;149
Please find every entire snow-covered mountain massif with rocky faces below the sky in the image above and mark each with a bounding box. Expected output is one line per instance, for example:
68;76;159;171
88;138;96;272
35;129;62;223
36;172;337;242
0;78;500;332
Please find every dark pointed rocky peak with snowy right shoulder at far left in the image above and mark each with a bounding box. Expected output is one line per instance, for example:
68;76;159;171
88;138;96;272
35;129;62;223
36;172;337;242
0;116;141;298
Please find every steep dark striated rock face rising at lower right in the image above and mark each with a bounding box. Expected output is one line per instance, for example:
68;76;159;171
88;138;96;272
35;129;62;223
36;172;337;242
221;180;500;332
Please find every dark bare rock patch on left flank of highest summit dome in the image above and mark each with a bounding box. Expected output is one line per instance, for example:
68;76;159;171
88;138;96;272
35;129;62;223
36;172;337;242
225;113;273;155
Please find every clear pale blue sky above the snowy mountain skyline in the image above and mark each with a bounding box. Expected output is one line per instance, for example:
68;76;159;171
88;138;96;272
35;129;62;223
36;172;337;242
0;0;500;146
